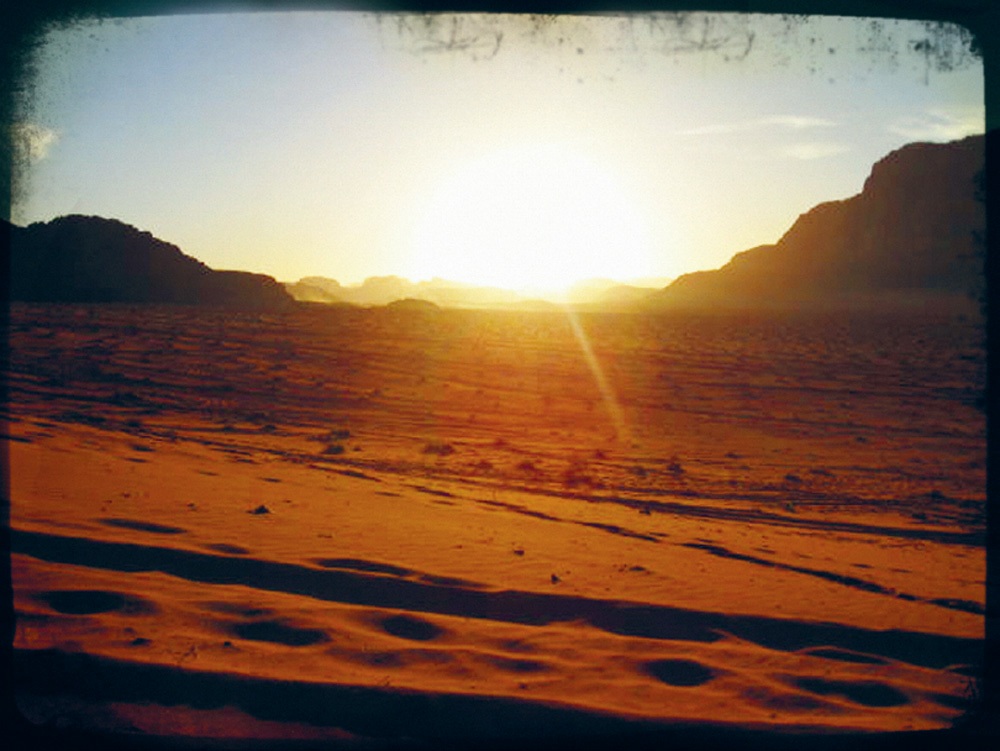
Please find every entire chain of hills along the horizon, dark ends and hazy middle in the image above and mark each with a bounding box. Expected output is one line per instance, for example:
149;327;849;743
2;135;986;312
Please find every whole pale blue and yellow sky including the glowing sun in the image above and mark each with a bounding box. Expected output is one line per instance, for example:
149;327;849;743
12;12;984;292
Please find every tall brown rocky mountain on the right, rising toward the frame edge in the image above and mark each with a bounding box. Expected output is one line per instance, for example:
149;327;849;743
649;136;986;308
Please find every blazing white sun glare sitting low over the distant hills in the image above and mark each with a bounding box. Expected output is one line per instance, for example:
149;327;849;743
407;144;652;295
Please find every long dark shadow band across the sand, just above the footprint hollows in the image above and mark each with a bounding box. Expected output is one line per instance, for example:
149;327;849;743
11;530;983;669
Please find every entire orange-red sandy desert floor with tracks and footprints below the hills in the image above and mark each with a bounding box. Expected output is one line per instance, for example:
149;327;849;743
8;306;985;742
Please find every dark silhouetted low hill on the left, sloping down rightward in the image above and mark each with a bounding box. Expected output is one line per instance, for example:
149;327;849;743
8;215;294;310
